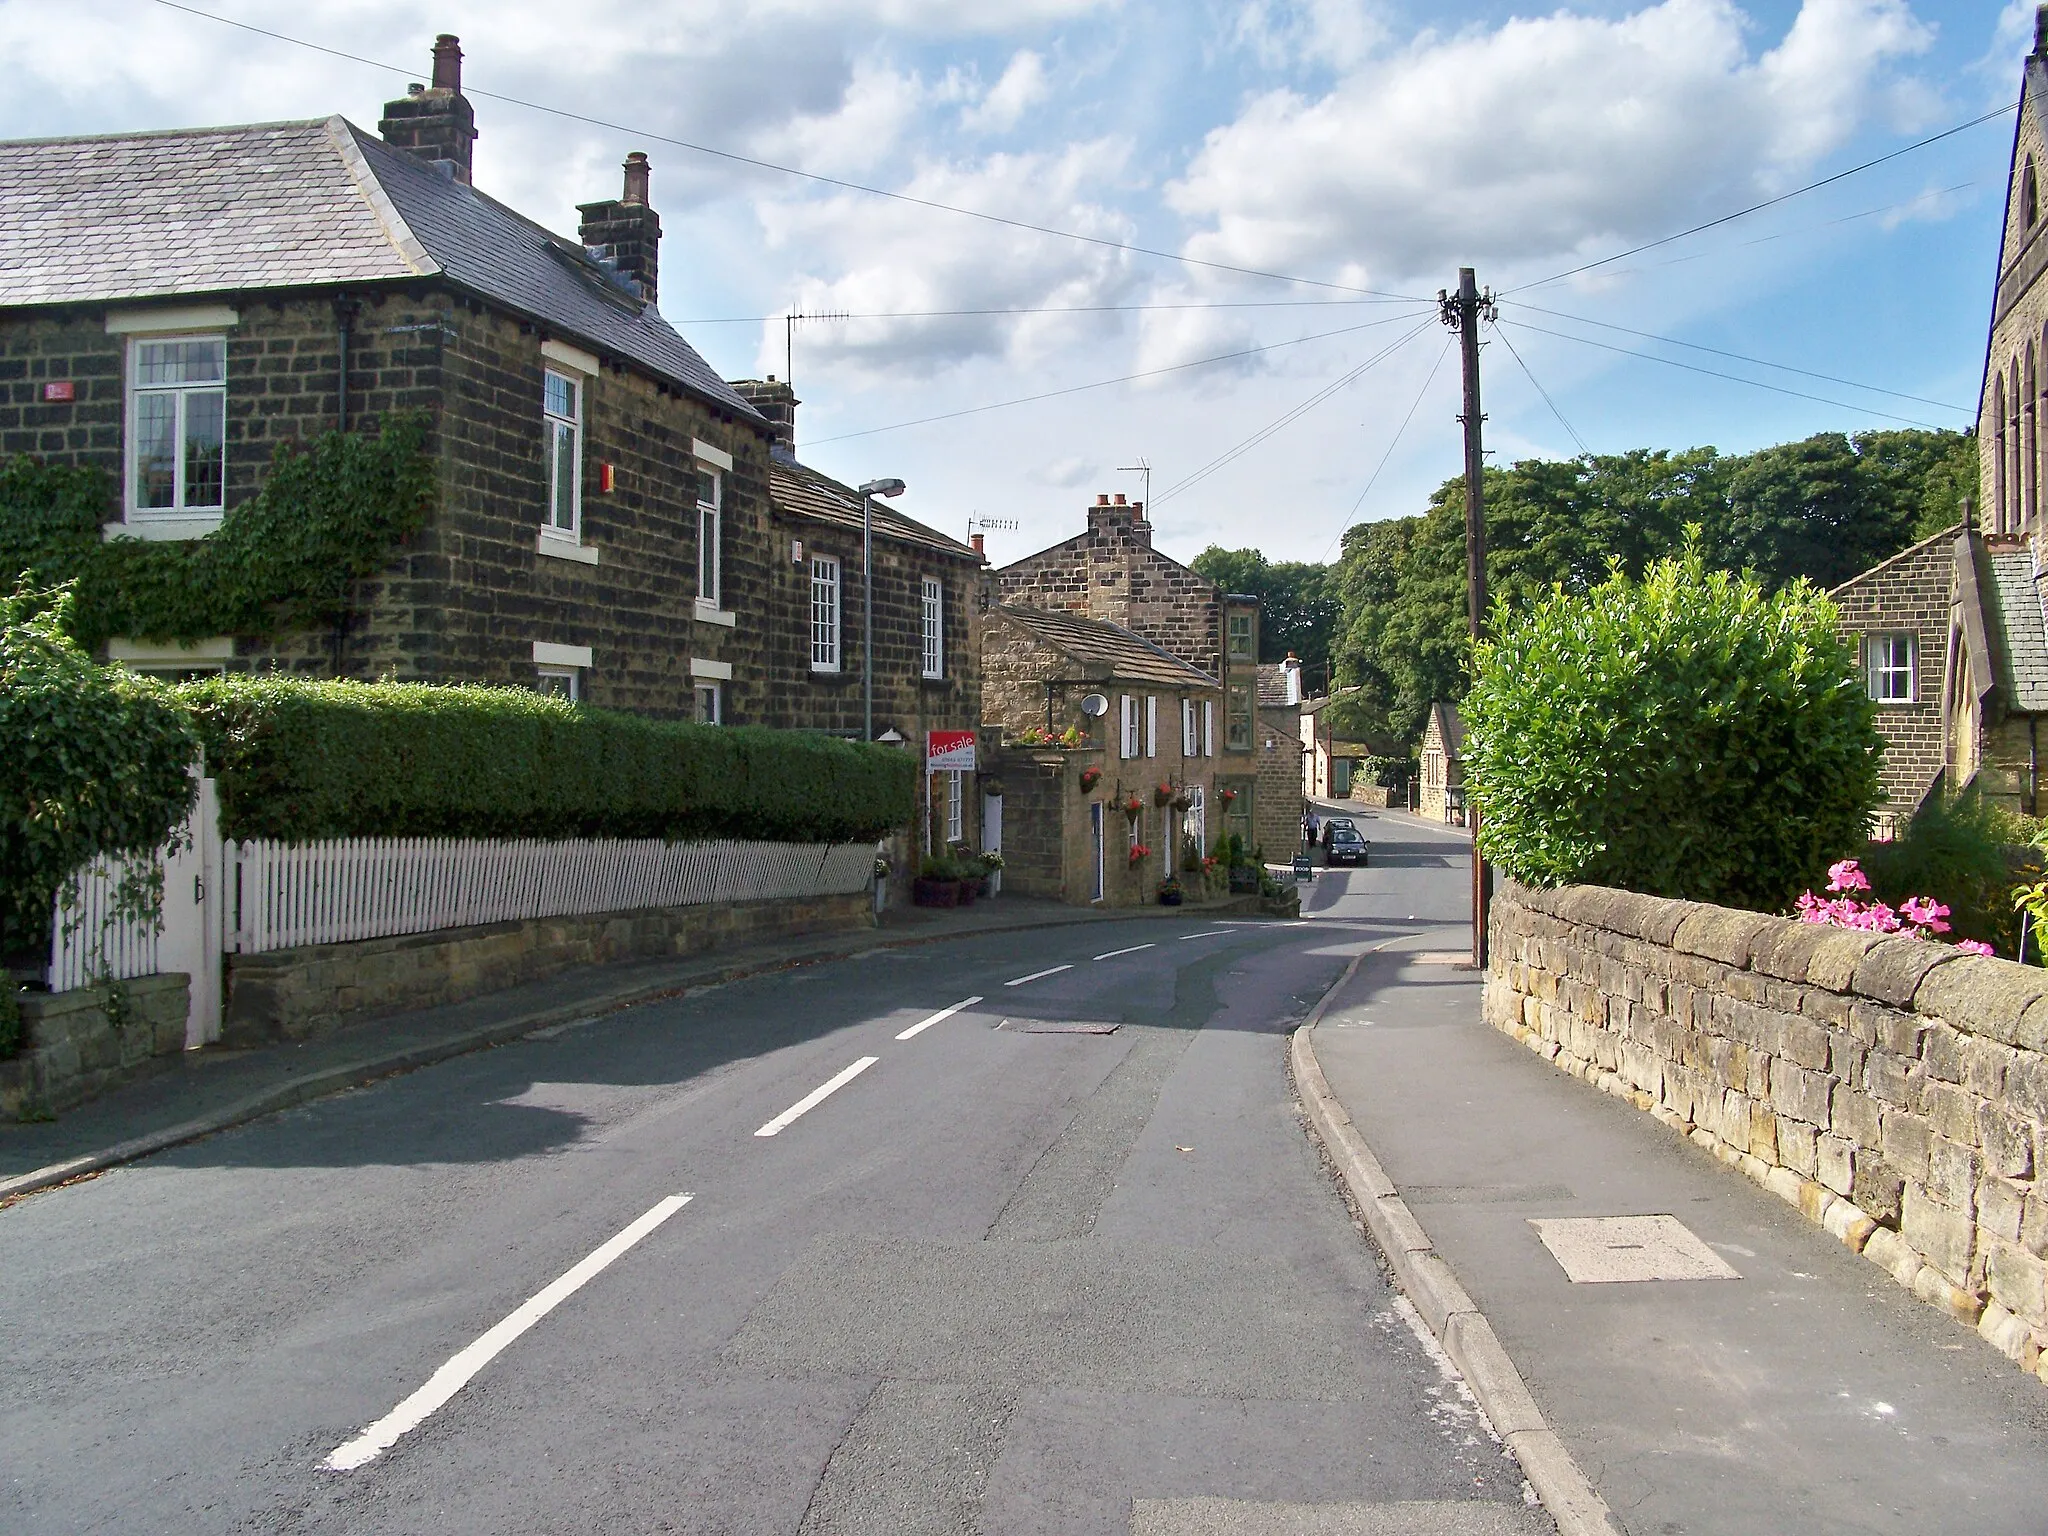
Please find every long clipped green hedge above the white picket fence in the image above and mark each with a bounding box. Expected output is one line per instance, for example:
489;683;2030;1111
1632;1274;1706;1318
178;674;918;842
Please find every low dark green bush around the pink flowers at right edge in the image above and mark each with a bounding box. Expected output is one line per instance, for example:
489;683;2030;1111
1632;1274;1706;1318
1860;788;2042;963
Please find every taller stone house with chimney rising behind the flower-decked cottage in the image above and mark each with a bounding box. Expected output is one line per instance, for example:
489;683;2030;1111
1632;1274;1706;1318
995;494;1303;858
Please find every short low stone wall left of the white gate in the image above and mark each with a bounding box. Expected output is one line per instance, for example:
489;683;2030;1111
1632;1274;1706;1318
0;971;188;1120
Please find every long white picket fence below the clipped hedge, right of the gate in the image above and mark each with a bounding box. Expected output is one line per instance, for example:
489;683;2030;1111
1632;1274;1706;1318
223;838;874;954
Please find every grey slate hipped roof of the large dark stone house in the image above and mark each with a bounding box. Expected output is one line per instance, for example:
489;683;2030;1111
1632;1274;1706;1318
0;117;760;420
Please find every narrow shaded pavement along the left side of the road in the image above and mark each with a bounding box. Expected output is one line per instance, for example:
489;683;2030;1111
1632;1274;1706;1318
0;895;1237;1202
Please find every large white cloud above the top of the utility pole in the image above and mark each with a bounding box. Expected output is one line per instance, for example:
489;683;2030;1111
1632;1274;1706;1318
1169;0;1931;285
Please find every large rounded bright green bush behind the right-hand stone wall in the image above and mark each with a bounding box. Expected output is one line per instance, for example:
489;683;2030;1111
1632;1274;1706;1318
1464;543;1882;911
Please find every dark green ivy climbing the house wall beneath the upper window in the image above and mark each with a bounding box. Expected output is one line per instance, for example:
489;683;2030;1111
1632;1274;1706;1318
0;412;436;649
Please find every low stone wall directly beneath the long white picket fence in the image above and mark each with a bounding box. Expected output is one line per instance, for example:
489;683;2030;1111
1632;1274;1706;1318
224;891;874;1047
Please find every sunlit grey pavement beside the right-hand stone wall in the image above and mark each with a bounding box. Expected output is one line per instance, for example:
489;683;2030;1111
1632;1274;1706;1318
1305;813;2048;1536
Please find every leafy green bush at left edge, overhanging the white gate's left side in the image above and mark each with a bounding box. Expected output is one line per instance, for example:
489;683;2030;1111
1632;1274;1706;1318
0;586;199;958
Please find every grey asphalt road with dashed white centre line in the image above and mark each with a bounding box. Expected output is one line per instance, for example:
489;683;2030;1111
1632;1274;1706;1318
0;823;1550;1536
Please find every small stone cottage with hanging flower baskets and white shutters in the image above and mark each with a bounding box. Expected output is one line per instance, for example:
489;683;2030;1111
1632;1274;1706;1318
981;604;1220;907
